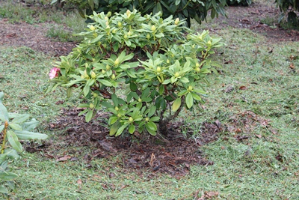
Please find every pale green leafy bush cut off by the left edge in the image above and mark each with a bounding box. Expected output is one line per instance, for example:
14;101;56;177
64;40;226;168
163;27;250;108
0;92;47;196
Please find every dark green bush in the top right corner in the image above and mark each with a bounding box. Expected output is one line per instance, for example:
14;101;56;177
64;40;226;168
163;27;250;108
275;0;299;26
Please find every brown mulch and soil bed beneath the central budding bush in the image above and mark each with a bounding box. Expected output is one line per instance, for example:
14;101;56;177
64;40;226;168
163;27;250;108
35;108;222;177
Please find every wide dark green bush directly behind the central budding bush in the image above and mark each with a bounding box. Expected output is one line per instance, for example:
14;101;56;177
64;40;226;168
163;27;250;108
52;0;226;26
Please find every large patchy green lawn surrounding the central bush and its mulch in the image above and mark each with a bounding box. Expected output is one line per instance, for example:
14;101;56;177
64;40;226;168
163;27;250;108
0;7;299;200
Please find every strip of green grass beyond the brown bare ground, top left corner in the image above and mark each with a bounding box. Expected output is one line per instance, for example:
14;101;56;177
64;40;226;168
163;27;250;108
0;0;86;42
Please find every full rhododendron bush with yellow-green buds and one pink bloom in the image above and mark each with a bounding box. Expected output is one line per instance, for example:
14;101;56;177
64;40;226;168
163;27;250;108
48;10;222;136
